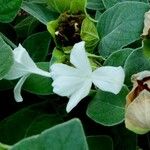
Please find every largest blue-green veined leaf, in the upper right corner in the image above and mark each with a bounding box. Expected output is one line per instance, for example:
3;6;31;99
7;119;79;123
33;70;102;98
97;2;150;56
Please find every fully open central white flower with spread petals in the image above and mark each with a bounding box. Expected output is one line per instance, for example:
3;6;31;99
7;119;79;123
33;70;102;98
50;42;125;112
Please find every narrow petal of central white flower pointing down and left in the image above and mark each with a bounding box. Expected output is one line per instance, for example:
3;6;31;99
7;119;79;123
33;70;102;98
66;80;92;112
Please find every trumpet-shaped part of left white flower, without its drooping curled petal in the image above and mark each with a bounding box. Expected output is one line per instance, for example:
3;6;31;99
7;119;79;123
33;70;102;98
4;44;50;80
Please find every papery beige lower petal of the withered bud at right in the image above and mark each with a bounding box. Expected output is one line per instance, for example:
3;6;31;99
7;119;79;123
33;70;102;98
125;90;150;134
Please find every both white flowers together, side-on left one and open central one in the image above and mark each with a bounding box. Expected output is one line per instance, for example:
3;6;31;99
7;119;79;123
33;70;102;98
5;41;125;112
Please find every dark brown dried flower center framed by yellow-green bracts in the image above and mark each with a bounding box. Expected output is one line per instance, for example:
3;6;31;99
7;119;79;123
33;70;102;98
55;12;85;46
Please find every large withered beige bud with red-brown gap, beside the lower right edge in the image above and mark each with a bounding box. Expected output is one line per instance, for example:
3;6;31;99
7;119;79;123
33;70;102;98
125;71;150;134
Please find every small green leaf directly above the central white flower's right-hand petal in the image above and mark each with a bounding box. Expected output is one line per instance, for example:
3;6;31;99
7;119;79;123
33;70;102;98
103;48;133;67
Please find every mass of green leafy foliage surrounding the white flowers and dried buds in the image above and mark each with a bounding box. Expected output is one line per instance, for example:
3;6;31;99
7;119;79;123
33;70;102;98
0;0;150;150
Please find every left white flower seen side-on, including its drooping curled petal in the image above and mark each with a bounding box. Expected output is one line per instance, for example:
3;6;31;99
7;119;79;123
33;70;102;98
4;44;50;102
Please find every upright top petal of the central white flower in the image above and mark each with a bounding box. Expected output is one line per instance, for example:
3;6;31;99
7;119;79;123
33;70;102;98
70;41;92;74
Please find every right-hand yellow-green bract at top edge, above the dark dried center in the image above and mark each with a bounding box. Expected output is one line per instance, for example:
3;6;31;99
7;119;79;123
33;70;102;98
70;0;87;14
